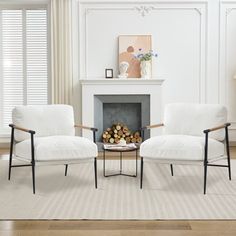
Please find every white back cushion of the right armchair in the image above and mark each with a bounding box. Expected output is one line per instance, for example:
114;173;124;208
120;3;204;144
164;103;227;141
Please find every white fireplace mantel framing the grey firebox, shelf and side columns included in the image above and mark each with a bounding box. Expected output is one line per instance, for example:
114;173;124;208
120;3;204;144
80;78;164;139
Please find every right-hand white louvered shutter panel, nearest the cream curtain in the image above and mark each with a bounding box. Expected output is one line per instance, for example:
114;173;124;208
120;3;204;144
26;10;48;105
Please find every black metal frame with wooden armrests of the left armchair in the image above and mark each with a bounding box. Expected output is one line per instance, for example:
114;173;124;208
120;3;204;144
8;124;98;194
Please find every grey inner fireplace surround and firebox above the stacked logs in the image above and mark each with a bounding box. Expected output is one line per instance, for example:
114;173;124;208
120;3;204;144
94;95;150;142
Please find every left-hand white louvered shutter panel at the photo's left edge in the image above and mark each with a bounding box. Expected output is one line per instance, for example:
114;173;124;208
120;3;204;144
1;10;23;127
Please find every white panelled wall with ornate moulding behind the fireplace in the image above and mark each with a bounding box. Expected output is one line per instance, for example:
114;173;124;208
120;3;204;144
75;0;236;141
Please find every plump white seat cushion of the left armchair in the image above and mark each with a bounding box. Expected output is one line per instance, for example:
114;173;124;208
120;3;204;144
15;136;98;161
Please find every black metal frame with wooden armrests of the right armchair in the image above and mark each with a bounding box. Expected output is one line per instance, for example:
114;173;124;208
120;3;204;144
140;123;231;194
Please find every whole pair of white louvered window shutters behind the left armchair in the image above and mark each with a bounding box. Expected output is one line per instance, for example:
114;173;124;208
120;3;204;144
0;9;48;134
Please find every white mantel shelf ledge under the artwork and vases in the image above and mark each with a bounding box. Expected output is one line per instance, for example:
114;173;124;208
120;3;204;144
80;77;164;85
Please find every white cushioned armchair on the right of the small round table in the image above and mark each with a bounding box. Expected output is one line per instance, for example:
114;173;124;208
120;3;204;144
140;103;231;194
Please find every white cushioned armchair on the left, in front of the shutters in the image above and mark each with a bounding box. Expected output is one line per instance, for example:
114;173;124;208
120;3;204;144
8;105;98;193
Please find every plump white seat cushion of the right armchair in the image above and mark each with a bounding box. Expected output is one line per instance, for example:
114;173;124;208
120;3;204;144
140;135;224;161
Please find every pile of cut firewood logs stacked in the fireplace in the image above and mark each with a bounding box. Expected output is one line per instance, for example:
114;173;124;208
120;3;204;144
102;123;142;144
